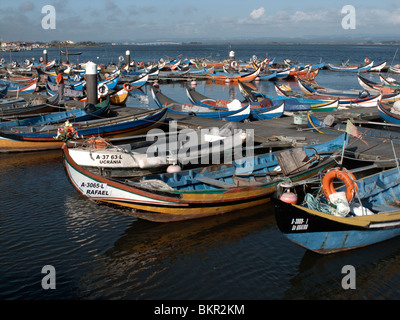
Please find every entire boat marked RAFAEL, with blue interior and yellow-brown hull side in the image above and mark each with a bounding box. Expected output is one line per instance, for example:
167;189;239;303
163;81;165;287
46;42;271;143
63;136;345;222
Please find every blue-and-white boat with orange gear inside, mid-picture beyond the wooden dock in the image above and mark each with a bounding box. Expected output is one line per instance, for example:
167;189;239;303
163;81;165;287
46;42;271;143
186;87;285;120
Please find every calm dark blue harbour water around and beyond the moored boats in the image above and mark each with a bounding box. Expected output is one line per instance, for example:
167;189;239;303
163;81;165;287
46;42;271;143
0;45;400;300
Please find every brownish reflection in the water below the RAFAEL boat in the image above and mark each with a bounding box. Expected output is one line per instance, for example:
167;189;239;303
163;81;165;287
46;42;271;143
105;204;275;272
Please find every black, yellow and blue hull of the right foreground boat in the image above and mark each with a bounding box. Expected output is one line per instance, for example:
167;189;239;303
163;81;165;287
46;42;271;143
272;198;400;254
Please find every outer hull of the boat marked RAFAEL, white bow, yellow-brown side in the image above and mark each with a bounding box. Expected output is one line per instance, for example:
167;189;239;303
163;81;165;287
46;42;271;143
63;146;335;222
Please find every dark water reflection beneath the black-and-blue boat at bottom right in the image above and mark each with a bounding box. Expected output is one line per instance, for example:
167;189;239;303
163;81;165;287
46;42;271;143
282;238;400;300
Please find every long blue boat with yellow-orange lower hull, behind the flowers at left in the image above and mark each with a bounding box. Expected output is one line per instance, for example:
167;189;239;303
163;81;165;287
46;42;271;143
0;108;167;152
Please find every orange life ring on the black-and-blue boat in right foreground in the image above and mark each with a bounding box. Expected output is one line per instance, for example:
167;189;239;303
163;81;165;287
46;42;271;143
322;168;358;202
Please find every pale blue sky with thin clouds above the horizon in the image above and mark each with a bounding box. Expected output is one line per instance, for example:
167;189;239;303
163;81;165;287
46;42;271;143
0;0;400;42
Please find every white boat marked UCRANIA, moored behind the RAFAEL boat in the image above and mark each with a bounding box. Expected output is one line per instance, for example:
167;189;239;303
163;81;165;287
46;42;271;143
69;122;247;177
